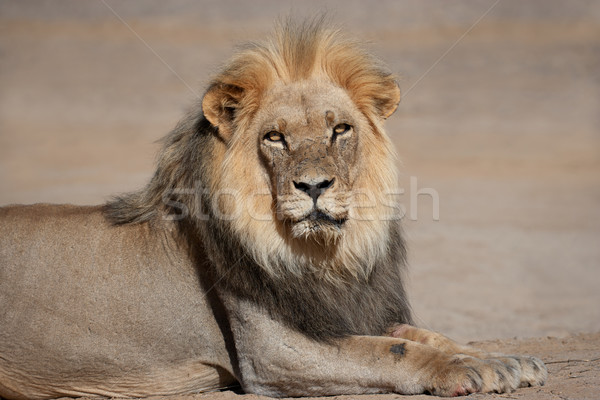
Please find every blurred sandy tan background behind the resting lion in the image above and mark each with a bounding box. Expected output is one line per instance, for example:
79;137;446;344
0;0;600;341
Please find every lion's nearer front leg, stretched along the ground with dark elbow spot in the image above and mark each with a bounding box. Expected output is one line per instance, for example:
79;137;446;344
225;298;536;397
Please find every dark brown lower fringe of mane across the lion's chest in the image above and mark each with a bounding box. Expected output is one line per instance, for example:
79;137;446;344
205;216;413;341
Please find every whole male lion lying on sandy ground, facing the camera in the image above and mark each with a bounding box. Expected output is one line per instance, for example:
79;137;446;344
0;21;547;400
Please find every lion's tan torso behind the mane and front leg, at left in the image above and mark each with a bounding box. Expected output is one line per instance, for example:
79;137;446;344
0;205;232;398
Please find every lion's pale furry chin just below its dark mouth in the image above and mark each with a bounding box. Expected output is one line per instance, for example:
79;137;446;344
291;211;346;244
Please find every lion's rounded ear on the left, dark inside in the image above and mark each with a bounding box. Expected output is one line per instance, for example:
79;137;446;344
202;83;243;140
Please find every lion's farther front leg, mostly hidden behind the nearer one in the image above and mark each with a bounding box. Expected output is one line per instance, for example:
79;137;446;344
388;324;548;387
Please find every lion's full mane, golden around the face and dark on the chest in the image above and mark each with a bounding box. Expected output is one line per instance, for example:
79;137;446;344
105;20;411;340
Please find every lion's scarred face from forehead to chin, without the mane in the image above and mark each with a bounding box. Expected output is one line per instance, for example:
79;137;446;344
254;82;364;240
